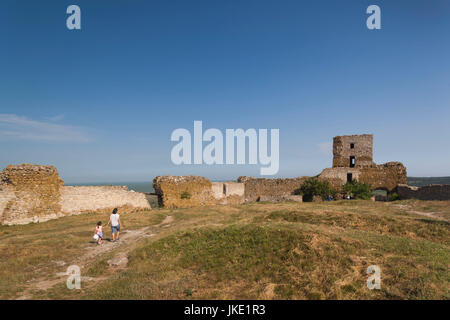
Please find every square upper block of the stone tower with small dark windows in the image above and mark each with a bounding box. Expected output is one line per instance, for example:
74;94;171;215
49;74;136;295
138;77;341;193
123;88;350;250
333;134;375;168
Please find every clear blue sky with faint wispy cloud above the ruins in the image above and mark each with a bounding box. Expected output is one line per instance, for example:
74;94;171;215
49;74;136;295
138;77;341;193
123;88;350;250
0;0;450;182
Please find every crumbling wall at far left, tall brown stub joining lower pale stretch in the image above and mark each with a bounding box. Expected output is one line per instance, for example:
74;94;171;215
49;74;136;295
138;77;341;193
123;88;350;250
0;164;150;224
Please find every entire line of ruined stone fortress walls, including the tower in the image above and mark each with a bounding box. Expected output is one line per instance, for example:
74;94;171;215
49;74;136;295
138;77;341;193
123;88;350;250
0;134;442;224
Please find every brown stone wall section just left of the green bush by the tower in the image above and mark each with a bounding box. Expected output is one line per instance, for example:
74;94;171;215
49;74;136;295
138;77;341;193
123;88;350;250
238;176;308;202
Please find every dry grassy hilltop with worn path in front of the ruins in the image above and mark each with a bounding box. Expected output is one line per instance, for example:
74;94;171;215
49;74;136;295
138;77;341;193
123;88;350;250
0;200;450;299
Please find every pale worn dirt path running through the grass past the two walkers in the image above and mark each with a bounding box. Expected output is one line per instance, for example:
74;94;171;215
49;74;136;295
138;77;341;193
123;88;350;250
16;216;174;300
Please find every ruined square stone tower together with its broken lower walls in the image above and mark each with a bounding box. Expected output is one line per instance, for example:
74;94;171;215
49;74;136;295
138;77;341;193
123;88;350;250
319;134;406;192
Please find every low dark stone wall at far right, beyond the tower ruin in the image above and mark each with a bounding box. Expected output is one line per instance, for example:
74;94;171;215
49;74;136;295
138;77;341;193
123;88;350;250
395;184;450;200
